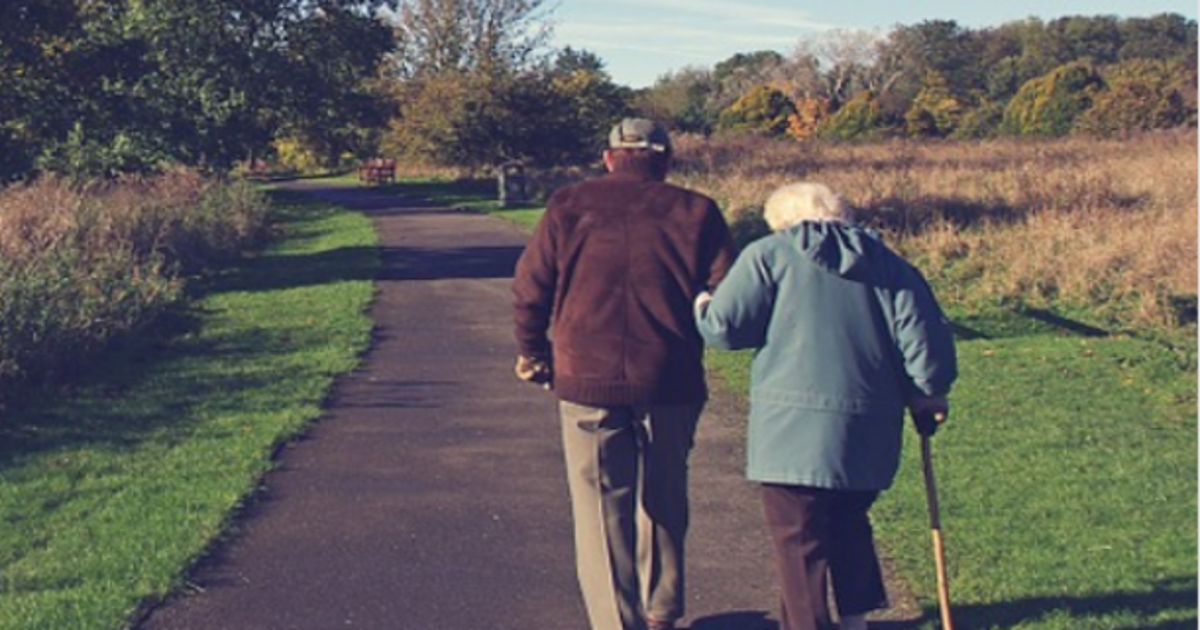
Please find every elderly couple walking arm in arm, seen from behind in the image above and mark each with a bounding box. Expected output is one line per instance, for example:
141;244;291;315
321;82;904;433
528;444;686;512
512;119;956;630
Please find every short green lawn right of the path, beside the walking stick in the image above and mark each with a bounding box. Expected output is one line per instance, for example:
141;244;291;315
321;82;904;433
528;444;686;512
405;176;1198;630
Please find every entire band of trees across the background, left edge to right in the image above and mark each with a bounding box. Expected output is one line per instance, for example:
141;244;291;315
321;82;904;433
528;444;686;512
0;0;1196;181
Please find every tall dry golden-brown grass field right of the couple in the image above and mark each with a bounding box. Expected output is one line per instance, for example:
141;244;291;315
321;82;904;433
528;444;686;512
672;130;1198;326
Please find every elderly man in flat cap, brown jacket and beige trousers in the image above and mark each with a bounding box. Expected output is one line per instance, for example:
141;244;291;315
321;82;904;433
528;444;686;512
512;119;736;630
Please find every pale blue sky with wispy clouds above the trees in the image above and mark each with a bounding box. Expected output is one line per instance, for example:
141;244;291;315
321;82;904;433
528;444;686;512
544;0;1198;88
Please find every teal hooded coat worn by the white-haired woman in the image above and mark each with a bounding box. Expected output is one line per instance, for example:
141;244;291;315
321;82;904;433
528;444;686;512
696;222;958;490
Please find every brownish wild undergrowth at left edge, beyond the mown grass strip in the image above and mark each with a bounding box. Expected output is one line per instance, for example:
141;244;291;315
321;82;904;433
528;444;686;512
0;170;266;404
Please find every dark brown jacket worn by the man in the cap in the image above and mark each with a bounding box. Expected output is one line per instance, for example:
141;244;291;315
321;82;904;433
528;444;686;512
512;172;736;406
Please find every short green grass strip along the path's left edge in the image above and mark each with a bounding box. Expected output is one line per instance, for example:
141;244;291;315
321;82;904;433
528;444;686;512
0;189;378;630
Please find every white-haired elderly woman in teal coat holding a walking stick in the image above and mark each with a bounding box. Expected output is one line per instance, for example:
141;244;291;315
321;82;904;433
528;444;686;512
696;182;958;630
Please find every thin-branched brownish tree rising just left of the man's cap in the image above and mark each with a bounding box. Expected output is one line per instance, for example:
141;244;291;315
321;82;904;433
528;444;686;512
390;0;628;170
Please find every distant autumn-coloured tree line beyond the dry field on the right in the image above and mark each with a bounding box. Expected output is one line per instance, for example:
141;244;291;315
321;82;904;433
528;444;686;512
641;13;1196;139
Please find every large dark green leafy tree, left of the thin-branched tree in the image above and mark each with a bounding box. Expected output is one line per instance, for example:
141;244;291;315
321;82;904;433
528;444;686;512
119;0;391;168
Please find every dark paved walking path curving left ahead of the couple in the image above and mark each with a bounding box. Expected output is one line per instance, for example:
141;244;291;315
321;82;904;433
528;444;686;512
140;182;912;630
